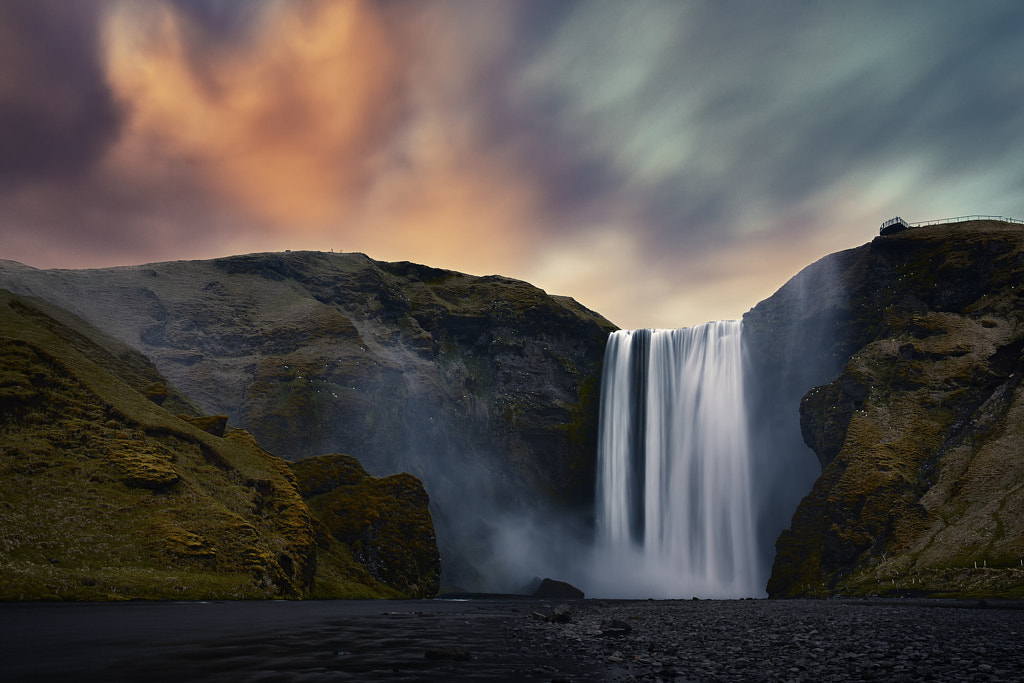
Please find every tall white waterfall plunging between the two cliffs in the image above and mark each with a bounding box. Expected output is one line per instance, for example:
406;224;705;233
596;321;764;598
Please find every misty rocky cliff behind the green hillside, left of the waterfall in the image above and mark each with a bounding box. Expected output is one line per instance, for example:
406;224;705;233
0;252;613;587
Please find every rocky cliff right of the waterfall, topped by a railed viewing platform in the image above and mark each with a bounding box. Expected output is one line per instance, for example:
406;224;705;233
744;221;1024;597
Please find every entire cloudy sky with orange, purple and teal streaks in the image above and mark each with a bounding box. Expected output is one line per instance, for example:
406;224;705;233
0;0;1024;328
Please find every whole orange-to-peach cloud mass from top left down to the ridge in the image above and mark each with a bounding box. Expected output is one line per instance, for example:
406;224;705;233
105;0;542;273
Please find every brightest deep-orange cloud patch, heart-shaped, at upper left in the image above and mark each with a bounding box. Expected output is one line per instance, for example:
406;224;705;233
105;0;400;229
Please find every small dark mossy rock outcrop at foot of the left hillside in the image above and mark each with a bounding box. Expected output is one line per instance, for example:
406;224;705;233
291;455;441;598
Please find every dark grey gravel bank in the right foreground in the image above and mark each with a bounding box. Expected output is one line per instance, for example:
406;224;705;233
514;600;1024;681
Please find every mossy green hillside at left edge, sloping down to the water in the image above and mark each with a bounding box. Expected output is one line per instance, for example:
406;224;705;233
0;291;436;600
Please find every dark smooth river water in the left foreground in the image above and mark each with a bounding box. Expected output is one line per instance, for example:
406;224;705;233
0;600;587;682
